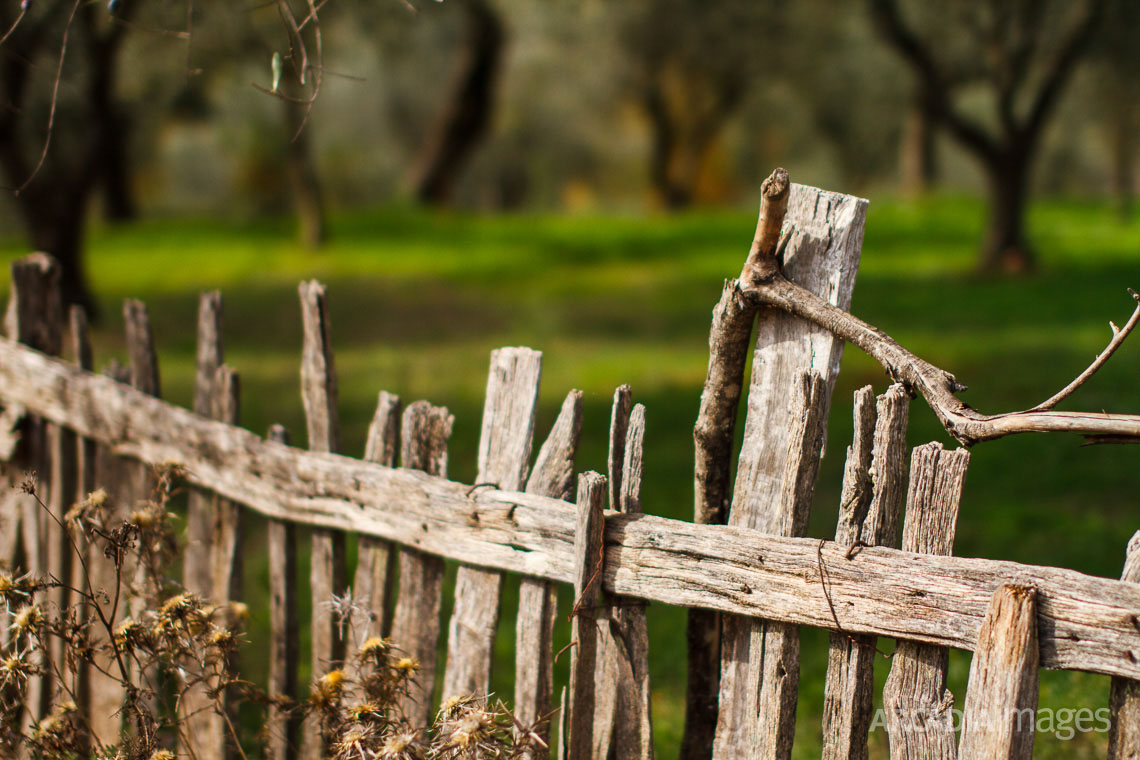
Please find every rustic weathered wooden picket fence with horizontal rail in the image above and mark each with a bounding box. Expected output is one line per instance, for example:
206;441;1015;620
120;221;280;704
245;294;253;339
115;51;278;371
0;186;1140;760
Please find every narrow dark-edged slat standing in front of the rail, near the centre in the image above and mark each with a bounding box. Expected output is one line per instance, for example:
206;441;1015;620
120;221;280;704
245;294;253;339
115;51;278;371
567;472;606;760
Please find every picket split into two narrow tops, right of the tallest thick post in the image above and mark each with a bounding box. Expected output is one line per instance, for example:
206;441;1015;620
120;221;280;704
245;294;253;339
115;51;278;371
822;384;909;760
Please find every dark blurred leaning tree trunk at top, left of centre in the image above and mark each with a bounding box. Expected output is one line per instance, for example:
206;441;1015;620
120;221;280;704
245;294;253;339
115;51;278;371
415;0;505;205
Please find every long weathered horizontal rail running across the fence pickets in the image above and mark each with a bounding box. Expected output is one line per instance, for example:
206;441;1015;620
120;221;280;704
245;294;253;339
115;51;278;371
0;341;1140;679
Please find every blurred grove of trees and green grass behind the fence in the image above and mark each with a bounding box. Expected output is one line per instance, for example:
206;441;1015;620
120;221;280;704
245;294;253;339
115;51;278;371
0;0;1140;758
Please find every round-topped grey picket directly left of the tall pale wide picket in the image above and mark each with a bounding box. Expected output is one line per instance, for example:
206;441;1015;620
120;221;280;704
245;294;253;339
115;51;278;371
391;401;455;726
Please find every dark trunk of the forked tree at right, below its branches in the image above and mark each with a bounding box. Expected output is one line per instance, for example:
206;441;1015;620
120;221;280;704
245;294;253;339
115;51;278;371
980;151;1036;273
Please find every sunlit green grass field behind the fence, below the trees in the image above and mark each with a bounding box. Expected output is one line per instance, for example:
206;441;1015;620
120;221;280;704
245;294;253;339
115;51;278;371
0;198;1140;758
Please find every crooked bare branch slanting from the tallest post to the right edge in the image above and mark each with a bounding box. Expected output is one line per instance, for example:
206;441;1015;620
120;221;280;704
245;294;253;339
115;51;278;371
744;273;1140;446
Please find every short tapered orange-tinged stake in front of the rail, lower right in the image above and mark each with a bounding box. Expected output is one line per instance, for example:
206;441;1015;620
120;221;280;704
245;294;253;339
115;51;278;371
958;583;1039;760
